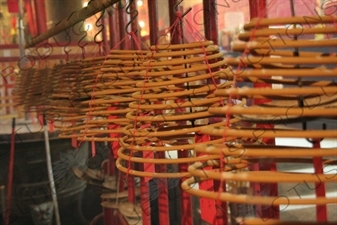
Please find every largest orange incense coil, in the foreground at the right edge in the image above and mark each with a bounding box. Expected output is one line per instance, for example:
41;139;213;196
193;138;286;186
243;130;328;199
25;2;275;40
182;17;337;224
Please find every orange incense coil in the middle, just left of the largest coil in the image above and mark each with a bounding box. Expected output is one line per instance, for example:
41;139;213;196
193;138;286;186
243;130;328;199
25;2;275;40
116;41;243;178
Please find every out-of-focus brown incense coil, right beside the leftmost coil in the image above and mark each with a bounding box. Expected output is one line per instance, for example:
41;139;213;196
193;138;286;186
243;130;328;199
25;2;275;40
51;57;105;138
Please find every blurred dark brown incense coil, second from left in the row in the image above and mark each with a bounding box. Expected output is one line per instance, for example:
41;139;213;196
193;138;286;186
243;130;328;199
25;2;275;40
46;58;104;138
